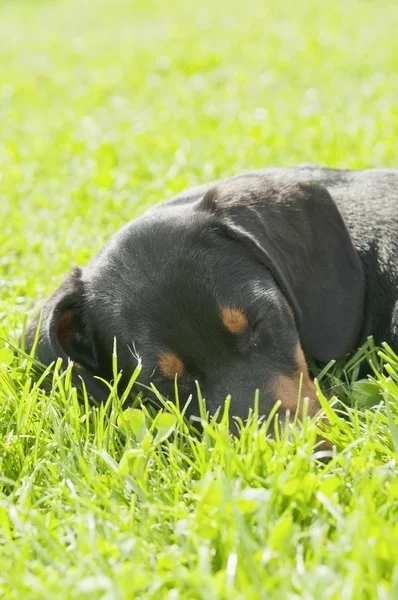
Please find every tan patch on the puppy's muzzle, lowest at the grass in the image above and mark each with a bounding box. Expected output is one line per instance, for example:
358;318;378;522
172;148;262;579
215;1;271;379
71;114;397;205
271;344;320;417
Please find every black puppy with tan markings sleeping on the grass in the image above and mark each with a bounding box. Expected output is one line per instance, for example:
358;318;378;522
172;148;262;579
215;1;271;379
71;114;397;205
27;166;398;419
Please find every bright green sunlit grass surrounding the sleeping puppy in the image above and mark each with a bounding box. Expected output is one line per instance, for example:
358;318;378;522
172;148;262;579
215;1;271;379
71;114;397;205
0;0;398;600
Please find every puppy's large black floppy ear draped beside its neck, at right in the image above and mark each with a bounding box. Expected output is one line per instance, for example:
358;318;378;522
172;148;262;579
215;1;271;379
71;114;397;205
198;178;364;362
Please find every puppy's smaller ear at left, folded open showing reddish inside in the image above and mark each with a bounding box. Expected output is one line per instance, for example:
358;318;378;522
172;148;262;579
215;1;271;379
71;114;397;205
26;268;109;401
